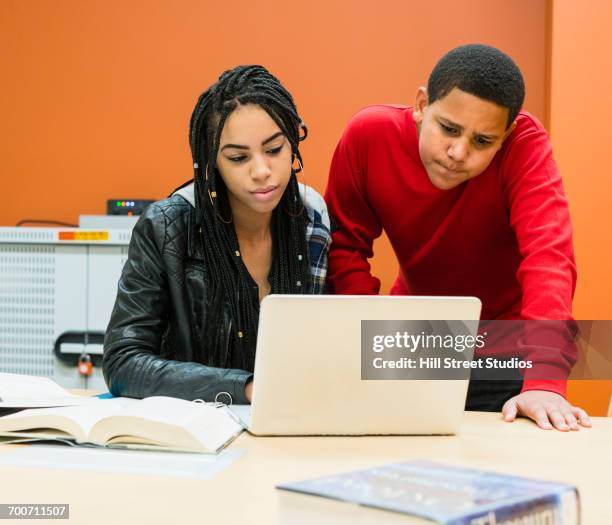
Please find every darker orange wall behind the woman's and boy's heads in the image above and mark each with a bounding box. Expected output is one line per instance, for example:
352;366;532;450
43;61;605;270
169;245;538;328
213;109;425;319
0;0;545;242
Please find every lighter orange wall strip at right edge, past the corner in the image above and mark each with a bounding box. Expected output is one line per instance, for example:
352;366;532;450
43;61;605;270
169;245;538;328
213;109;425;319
550;0;612;415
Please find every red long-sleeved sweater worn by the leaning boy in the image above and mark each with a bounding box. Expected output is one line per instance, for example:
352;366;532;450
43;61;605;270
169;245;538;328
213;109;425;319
325;105;576;395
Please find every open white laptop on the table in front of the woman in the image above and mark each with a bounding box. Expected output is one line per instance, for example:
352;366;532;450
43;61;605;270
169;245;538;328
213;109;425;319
231;295;481;436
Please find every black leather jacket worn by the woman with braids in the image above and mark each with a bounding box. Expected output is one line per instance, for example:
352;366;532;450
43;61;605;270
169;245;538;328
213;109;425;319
103;186;329;404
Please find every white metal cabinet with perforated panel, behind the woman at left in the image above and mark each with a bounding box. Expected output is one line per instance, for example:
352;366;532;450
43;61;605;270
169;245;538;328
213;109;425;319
0;227;131;390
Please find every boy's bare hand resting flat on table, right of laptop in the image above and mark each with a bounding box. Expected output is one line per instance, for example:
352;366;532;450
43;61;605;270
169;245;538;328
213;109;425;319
502;390;591;432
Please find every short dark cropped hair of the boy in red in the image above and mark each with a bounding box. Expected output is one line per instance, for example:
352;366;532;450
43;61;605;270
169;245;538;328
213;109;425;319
427;44;525;129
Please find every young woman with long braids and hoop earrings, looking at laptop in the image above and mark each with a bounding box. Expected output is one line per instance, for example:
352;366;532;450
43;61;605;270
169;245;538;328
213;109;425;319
104;66;331;403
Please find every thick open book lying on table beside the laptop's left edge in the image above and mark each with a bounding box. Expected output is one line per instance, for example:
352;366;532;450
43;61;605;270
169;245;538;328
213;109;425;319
0;396;243;453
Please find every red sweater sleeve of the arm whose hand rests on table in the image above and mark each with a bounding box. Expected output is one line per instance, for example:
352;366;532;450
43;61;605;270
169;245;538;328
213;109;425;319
501;112;577;396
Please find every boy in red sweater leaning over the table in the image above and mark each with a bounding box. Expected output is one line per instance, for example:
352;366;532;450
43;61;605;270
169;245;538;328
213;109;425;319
326;45;590;430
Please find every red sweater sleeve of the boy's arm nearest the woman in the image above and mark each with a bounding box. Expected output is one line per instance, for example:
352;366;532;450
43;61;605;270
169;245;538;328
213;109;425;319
325;111;382;295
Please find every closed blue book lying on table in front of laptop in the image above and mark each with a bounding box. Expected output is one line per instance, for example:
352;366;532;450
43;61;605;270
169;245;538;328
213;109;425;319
277;461;580;525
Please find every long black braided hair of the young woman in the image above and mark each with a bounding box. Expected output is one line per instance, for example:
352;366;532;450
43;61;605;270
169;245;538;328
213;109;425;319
189;65;313;370
